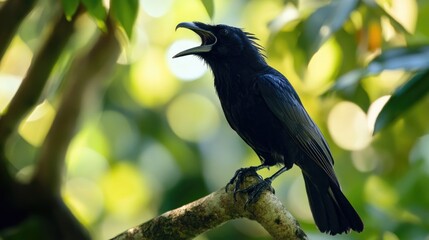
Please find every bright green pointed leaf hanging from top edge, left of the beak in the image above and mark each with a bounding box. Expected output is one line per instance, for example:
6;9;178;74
110;0;139;38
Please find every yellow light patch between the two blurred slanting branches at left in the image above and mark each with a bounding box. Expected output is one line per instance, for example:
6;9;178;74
18;100;56;146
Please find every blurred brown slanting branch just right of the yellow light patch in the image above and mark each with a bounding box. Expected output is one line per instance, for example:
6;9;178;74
33;16;120;195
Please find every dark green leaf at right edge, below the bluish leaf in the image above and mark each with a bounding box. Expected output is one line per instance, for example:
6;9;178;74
374;70;429;134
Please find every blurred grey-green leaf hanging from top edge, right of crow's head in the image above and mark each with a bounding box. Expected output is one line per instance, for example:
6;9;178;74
299;0;359;59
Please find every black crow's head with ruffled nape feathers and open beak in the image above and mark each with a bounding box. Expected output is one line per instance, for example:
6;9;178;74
174;22;263;63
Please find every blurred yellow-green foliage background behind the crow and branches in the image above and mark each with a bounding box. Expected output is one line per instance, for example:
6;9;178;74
0;0;429;240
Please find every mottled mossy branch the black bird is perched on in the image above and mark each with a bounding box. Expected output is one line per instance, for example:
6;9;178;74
112;176;307;240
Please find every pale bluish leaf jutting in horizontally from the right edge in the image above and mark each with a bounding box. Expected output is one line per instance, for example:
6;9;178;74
367;46;429;74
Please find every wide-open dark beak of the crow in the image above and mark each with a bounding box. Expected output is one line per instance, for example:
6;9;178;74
173;22;217;58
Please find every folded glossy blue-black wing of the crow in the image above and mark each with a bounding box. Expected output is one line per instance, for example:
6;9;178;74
256;72;339;185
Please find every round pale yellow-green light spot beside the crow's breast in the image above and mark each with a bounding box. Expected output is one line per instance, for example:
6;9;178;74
167;93;219;141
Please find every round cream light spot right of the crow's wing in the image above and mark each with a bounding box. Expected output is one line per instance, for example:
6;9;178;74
328;101;371;150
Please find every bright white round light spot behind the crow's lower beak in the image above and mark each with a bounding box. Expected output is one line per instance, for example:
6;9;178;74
167;40;208;81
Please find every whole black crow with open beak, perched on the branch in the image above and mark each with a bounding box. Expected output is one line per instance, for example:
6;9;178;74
175;22;363;234
